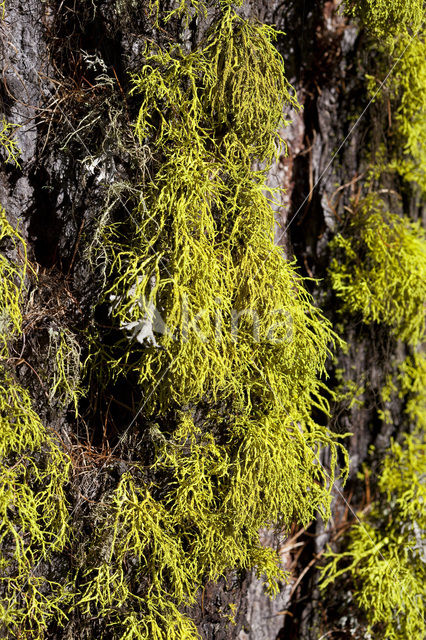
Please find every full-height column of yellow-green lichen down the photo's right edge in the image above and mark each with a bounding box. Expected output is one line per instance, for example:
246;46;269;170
321;1;426;640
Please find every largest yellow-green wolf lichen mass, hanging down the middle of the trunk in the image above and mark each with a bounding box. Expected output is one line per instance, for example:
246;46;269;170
83;3;350;640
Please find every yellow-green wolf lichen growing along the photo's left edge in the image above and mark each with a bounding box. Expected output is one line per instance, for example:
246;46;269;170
0;209;70;640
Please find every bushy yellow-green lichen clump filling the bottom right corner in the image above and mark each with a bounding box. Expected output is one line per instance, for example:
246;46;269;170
321;431;426;640
